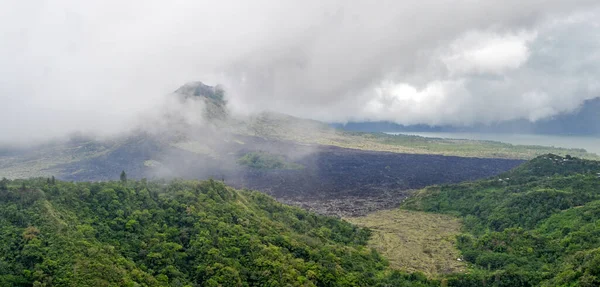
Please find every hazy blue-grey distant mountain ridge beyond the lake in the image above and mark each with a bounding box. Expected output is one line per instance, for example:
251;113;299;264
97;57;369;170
331;98;600;136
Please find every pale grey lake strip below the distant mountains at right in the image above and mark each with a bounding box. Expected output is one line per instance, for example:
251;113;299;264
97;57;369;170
386;132;600;155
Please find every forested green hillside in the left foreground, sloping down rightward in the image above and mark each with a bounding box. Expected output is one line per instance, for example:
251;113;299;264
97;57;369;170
0;179;439;286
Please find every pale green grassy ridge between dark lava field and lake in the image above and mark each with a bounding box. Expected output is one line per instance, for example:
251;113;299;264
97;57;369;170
237;113;600;160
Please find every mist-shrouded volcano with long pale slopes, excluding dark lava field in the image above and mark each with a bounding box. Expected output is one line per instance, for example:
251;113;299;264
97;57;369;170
0;82;600;184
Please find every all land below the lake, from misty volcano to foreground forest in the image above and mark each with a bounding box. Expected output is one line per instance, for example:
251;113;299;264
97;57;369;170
0;83;600;287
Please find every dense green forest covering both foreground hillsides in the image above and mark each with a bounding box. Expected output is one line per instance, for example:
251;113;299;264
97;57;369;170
0;155;600;287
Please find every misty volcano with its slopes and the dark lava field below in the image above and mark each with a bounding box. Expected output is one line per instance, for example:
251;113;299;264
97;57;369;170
0;82;572;216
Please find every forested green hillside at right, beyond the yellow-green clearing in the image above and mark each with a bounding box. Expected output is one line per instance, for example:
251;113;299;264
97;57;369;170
403;155;600;286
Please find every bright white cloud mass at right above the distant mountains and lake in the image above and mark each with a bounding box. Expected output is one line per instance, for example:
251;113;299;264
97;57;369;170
352;12;600;125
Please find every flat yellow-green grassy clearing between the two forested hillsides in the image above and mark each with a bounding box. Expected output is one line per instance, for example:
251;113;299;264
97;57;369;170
346;209;467;278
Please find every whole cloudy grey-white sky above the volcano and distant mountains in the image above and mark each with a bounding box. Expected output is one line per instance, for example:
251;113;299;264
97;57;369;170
0;0;600;141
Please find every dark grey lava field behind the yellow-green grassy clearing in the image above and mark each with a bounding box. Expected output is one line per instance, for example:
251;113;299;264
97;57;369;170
226;147;523;216
